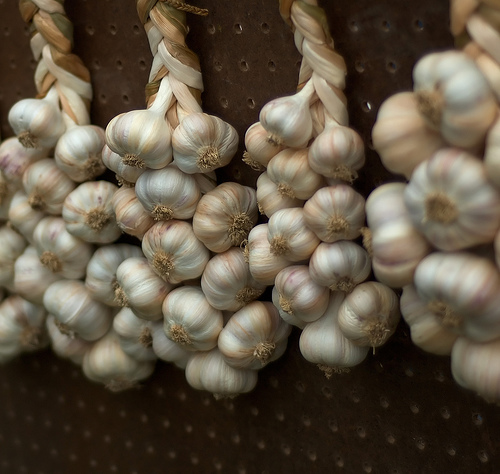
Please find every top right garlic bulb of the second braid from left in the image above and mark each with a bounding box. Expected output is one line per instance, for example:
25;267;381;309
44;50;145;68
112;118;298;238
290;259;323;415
172;113;238;174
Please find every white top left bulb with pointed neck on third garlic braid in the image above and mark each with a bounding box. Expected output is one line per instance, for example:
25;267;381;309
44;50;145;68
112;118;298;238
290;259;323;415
259;80;314;148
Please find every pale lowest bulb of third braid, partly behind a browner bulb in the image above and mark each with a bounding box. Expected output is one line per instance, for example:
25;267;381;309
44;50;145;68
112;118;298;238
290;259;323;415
299;292;369;377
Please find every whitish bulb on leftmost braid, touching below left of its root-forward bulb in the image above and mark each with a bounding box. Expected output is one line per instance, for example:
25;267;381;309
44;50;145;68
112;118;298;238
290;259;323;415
33;217;94;280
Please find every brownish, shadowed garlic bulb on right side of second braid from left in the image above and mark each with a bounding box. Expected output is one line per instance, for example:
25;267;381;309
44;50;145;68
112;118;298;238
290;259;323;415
193;182;258;253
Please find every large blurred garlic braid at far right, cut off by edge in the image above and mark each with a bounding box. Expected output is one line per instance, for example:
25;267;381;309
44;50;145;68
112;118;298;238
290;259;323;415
366;0;500;402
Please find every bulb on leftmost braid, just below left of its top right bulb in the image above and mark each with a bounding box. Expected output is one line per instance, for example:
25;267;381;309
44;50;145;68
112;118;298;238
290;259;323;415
23;158;75;216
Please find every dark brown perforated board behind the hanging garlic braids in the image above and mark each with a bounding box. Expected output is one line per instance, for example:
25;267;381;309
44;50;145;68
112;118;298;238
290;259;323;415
0;0;500;474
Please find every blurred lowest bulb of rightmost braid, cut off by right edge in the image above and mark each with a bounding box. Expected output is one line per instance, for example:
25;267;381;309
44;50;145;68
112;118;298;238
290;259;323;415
451;337;500;403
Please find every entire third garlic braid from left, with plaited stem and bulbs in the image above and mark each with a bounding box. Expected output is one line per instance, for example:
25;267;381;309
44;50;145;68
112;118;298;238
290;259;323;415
244;0;400;375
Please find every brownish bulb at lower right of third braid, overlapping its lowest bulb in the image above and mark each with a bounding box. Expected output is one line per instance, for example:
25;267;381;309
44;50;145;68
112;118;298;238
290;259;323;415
338;281;401;347
